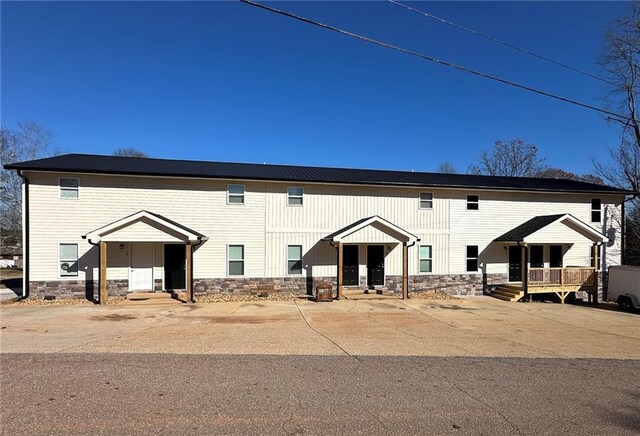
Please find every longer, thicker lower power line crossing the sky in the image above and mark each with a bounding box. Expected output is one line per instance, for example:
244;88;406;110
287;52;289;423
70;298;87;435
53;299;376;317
240;0;635;121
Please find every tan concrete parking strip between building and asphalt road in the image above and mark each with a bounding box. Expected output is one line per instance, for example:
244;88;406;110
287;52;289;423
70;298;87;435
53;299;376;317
0;297;640;359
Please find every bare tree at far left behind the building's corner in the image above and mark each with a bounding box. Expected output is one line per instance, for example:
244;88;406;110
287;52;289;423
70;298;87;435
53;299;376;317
0;121;57;247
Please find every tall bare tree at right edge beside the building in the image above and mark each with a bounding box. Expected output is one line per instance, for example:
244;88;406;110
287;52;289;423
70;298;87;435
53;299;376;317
593;2;640;264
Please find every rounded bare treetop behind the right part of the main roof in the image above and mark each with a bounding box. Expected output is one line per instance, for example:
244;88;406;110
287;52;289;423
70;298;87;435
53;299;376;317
469;139;545;177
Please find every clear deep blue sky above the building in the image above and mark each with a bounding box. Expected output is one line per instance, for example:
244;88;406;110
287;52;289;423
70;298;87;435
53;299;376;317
1;1;628;173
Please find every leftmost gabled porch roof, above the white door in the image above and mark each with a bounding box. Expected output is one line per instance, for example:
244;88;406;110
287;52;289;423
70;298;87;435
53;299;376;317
82;210;209;243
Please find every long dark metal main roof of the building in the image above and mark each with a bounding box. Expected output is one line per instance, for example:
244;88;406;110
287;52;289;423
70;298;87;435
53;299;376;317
4;154;634;194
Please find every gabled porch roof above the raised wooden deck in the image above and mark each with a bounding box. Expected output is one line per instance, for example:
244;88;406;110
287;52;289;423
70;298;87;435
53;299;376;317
494;213;609;243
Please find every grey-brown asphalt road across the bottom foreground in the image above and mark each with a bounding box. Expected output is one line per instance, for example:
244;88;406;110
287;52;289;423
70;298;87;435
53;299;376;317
0;353;640;436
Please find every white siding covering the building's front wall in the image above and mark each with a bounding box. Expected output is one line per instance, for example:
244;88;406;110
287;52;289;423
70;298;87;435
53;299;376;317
29;173;621;281
